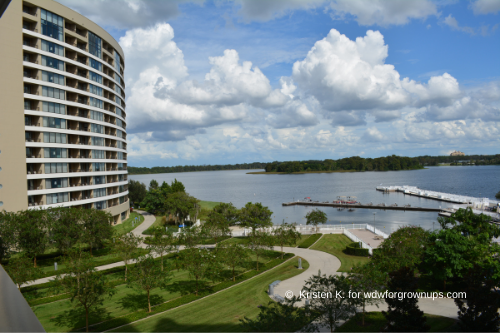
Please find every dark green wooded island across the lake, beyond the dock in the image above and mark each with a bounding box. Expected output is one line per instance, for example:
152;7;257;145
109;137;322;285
265;155;423;173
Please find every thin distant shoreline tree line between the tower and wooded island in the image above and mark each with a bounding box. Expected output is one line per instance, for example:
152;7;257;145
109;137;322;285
127;162;266;175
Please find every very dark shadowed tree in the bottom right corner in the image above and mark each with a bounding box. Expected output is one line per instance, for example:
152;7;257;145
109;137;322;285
455;265;500;332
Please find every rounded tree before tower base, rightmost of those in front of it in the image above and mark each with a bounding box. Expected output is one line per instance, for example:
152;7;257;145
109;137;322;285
82;208;113;255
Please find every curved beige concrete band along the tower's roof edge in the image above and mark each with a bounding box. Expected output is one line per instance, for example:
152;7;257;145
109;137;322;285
25;0;126;61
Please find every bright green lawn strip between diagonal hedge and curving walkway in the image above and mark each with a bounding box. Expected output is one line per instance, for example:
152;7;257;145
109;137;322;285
115;258;309;332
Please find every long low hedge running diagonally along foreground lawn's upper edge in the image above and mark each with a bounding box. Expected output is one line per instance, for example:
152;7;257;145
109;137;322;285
75;253;295;332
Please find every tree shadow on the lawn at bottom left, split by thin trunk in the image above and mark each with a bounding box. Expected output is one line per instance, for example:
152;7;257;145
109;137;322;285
50;307;111;331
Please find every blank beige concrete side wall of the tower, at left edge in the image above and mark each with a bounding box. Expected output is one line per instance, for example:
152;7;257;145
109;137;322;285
0;0;28;211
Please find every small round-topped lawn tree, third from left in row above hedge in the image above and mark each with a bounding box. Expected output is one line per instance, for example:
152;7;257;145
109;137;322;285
180;247;216;295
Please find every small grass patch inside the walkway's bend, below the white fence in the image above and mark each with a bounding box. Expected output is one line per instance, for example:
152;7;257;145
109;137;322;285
311;234;370;272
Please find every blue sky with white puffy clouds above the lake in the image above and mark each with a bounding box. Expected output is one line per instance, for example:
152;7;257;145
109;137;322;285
56;0;500;167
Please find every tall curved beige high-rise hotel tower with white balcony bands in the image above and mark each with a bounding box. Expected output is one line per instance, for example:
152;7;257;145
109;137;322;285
0;0;129;223
